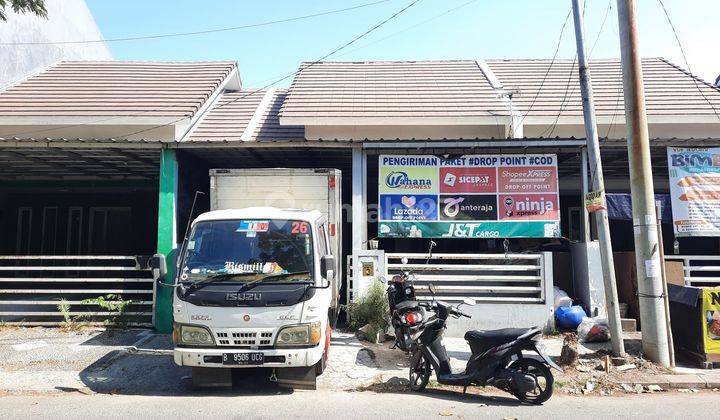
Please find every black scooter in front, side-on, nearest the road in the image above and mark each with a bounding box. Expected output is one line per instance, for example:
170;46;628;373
410;284;562;404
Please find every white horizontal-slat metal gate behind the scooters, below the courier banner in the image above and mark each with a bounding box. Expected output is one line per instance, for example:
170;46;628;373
385;253;552;303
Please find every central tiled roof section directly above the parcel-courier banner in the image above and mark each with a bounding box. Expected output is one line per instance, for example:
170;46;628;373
280;60;508;124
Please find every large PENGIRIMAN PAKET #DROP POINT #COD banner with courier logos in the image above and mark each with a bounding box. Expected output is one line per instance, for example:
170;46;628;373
378;154;560;238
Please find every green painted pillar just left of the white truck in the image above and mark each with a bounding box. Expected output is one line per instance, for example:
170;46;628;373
155;149;178;333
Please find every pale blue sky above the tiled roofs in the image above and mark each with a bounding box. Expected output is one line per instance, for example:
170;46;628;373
87;0;720;88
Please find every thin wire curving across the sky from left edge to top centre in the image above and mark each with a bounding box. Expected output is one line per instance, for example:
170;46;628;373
0;0;391;46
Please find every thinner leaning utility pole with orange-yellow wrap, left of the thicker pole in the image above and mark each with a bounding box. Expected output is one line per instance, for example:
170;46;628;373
572;0;625;356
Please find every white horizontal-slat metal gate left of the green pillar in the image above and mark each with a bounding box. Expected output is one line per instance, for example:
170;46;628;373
0;255;155;326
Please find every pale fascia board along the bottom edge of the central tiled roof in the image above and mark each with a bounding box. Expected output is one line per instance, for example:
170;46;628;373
280;115;506;126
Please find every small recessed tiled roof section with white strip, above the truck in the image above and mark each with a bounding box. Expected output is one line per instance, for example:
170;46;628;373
187;89;305;142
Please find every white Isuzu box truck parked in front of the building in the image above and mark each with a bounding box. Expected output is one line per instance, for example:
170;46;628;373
165;168;341;389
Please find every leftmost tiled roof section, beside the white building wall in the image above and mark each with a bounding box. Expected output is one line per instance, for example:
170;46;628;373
0;61;236;118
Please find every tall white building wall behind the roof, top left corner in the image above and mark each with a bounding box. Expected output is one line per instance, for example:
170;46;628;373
0;0;112;87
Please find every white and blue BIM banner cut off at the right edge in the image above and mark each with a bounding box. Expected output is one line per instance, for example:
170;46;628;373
667;147;720;236
